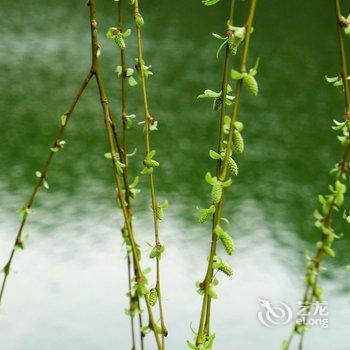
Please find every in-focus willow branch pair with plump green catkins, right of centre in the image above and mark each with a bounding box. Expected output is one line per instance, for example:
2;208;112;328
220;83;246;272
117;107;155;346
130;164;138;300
196;0;257;346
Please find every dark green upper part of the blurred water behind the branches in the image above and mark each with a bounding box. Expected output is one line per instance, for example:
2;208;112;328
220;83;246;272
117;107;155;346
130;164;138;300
0;0;350;349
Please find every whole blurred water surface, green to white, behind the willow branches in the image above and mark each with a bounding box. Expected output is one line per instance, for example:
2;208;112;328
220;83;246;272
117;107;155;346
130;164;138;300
0;0;350;350
